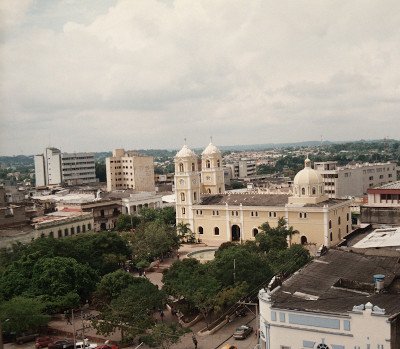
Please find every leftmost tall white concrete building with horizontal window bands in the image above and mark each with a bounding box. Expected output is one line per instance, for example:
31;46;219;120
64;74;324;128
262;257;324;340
34;148;97;187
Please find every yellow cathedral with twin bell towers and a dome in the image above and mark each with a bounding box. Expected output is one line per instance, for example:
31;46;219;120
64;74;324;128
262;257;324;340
174;143;351;248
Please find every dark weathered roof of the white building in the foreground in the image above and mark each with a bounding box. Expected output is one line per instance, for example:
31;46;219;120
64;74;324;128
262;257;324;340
271;250;400;315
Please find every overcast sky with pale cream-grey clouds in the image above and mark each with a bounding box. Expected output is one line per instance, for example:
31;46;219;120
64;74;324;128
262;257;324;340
0;0;400;155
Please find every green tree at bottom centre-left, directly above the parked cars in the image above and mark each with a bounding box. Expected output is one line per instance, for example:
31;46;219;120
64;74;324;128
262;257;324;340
93;278;166;342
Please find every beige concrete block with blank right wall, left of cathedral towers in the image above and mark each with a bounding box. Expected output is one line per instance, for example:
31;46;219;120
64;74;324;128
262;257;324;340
106;149;155;192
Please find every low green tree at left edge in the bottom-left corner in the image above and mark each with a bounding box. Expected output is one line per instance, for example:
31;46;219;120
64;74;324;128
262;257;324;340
0;296;50;334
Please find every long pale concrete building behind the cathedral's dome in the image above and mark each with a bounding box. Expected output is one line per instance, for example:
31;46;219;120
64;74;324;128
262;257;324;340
314;161;398;198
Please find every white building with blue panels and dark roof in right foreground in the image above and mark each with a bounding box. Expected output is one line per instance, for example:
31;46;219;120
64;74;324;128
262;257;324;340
259;250;400;349
